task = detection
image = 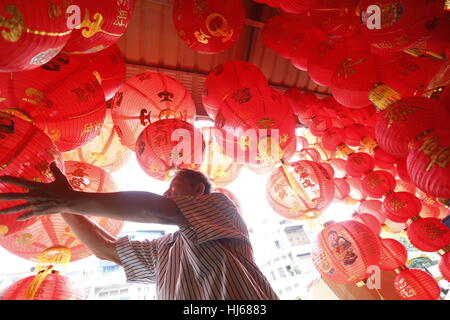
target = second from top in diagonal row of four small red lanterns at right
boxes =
[362,170,395,198]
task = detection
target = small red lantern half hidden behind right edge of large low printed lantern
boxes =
[380,238,408,271]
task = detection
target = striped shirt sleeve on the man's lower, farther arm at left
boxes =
[116,236,158,283]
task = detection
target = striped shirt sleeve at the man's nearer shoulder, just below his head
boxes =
[172,192,249,244]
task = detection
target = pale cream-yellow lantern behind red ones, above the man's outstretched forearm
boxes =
[62,109,131,173]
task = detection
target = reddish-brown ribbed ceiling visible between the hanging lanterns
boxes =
[117,0,330,116]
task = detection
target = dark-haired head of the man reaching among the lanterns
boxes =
[164,169,211,197]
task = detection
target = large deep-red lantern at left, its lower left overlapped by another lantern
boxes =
[0,54,106,151]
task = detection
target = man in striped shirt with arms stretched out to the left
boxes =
[0,163,278,300]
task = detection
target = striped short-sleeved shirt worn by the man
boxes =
[116,193,278,300]
